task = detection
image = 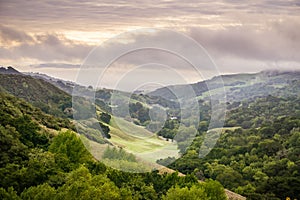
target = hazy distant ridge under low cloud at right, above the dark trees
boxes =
[149,71,300,102]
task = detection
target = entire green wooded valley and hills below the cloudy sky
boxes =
[0,69,300,200]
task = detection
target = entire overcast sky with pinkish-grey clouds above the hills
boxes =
[0,0,300,87]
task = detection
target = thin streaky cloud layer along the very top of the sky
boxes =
[0,0,300,31]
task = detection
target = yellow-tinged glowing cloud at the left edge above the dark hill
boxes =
[0,26,93,62]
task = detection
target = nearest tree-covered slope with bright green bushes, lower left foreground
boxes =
[0,92,226,200]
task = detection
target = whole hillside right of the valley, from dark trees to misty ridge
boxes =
[149,71,300,199]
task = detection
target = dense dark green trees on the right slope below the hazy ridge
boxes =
[169,96,300,199]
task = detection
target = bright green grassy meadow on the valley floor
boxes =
[77,117,178,168]
